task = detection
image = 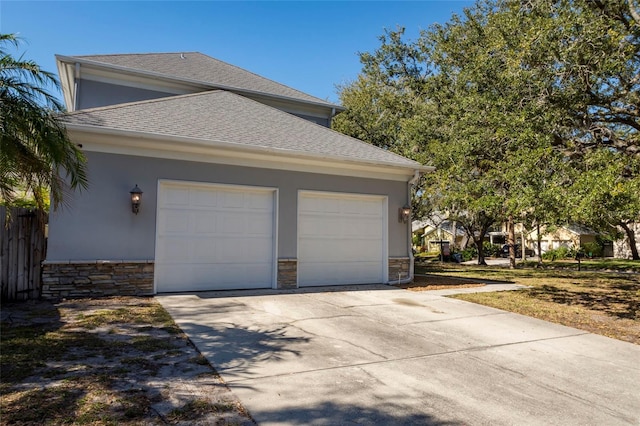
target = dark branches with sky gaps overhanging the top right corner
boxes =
[540,0,640,155]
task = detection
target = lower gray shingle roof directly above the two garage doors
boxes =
[64,90,421,168]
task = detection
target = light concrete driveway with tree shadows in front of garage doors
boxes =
[158,286,640,425]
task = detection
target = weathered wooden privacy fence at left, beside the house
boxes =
[0,206,46,302]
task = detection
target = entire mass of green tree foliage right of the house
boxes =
[334,0,640,263]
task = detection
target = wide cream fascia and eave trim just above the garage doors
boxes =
[67,124,433,181]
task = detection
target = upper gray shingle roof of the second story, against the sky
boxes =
[71,52,336,107]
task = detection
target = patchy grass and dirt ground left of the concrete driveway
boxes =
[0,297,254,425]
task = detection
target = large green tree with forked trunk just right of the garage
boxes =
[336,3,564,265]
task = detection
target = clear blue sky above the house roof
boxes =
[0,0,472,102]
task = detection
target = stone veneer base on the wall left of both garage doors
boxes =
[41,260,154,299]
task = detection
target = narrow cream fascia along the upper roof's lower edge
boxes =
[56,55,345,111]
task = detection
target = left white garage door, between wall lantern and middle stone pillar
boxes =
[155,182,275,292]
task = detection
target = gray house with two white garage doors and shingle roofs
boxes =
[43,52,429,297]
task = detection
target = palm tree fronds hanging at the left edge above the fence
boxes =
[0,34,87,215]
